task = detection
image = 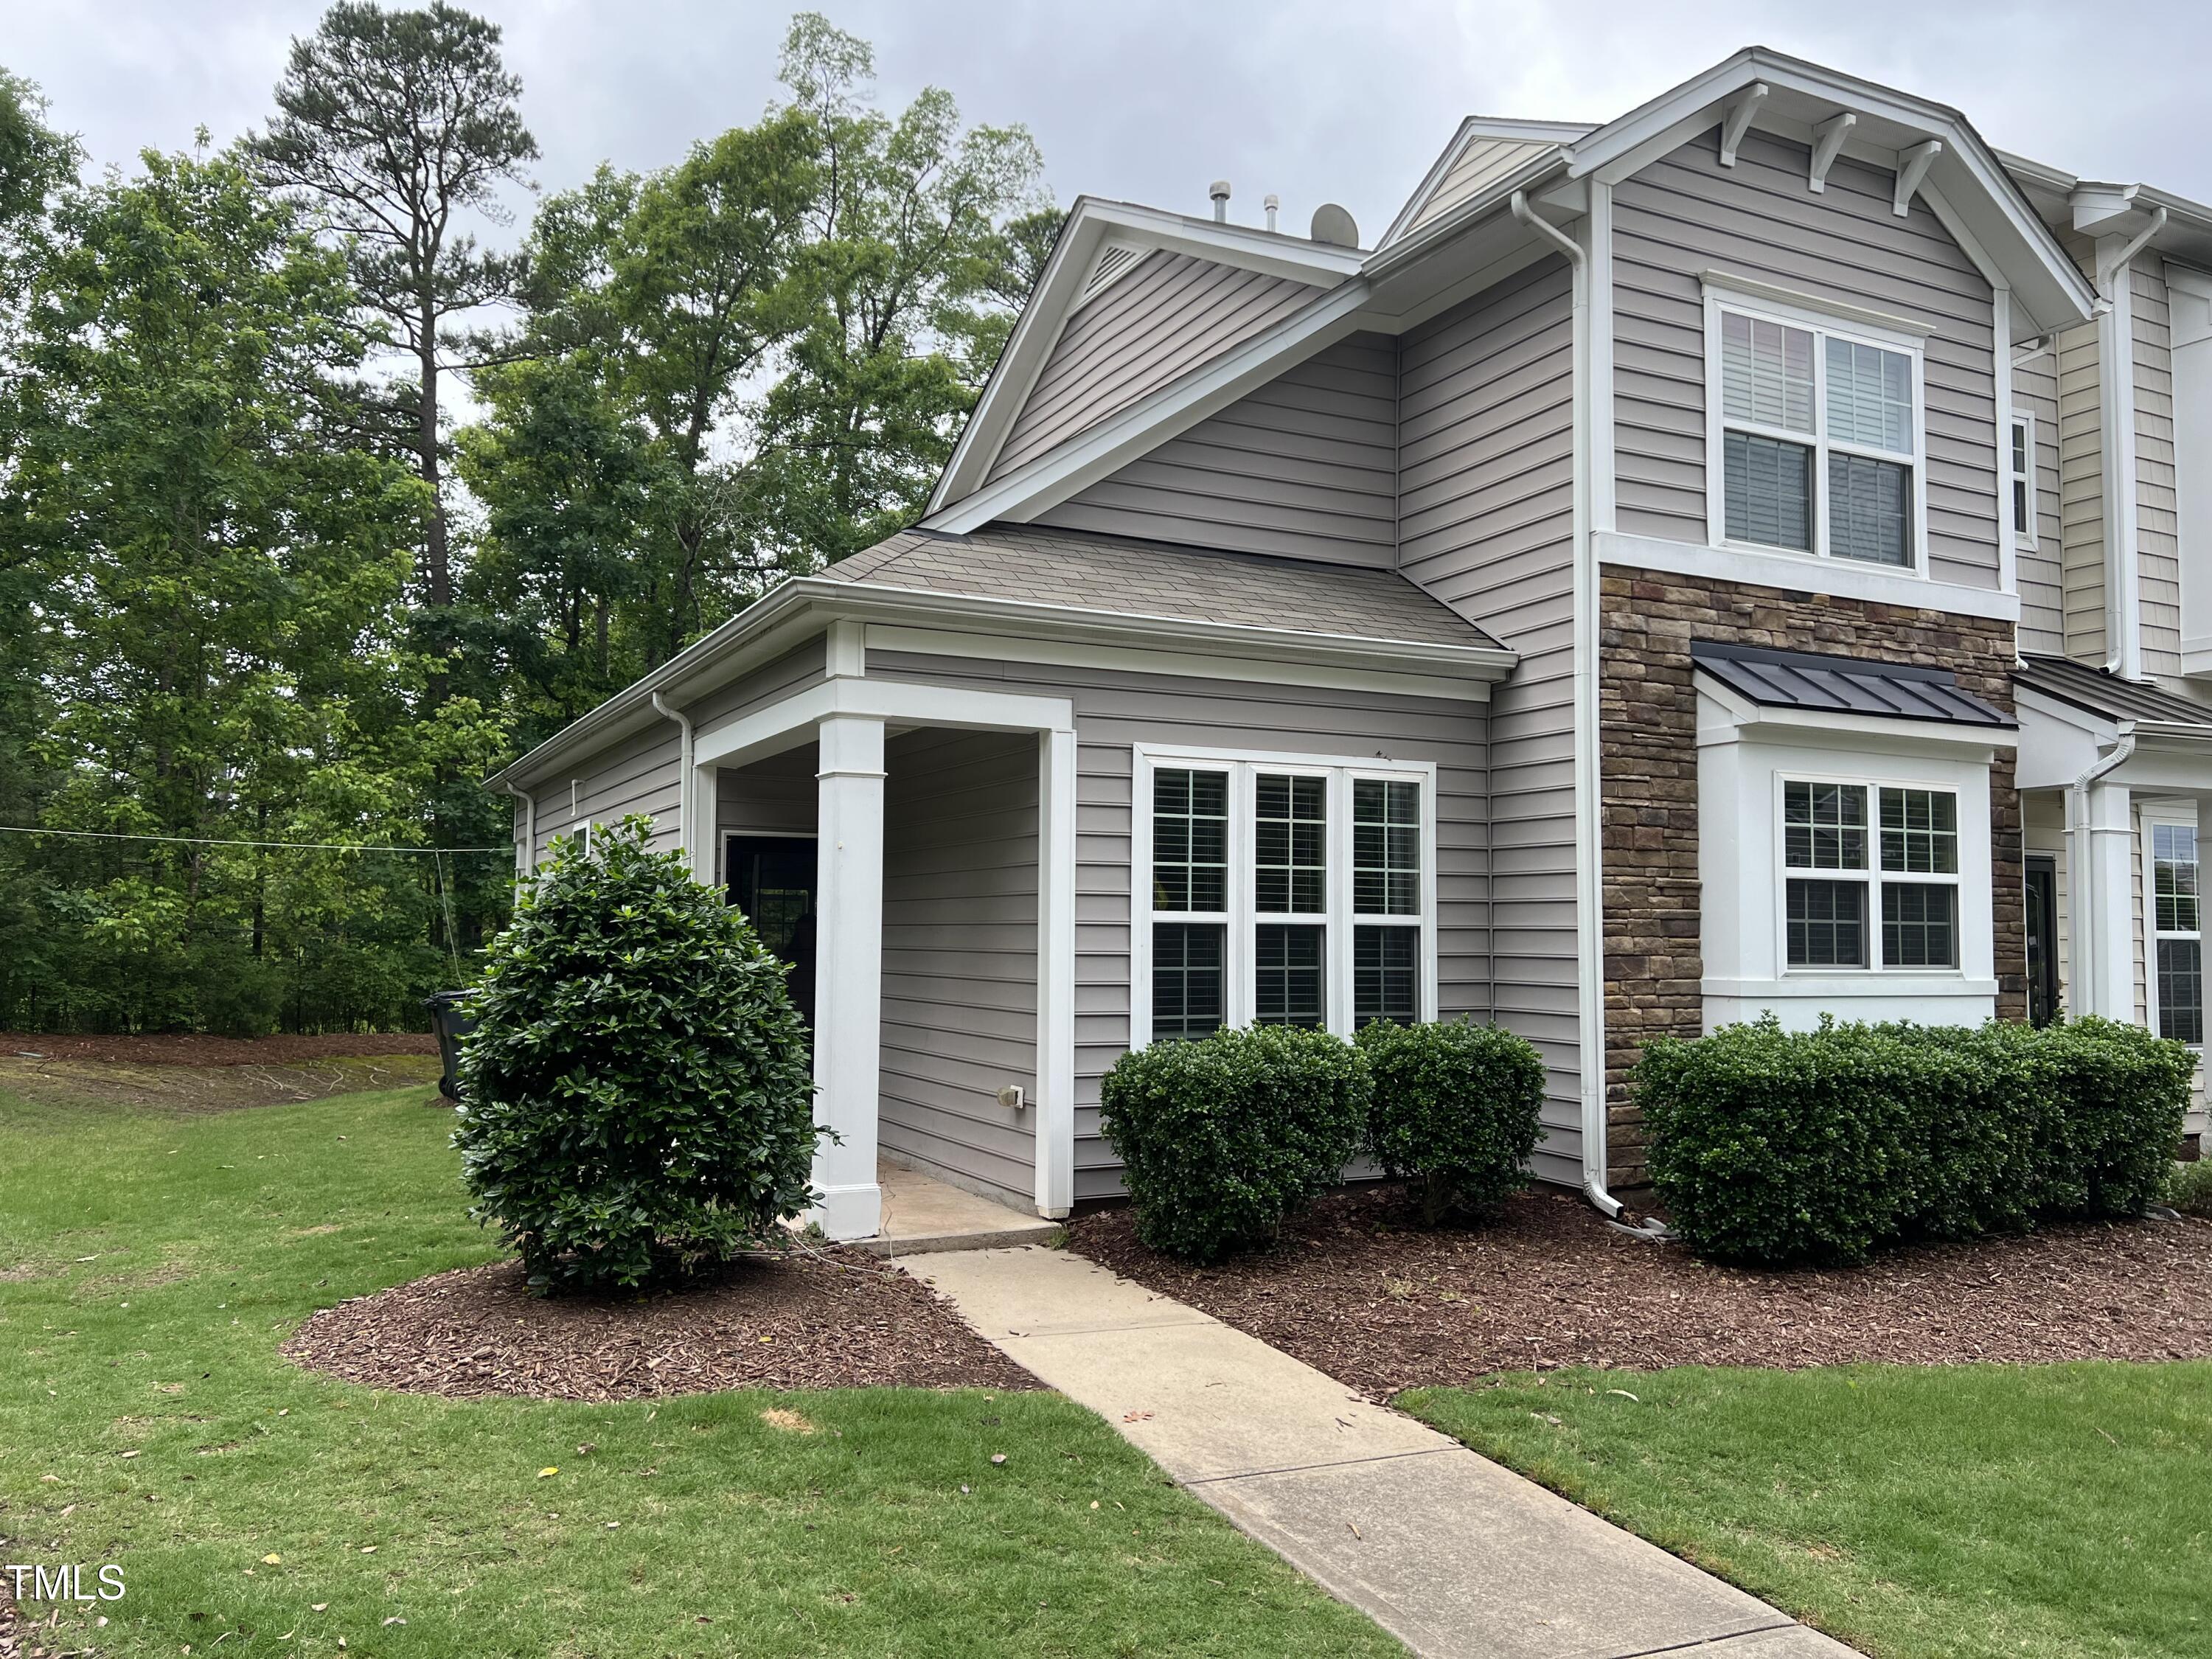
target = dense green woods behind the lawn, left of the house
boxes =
[0,0,1060,1033]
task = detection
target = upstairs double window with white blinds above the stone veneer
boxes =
[1705,288,1924,571]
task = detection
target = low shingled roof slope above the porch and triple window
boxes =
[823,526,1502,650]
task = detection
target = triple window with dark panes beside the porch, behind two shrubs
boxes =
[1133,748,1436,1044]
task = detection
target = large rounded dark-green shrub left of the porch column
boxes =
[453,818,818,1290]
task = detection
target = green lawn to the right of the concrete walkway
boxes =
[1400,1365,2212,1659]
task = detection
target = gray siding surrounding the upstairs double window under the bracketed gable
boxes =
[1613,133,2000,588]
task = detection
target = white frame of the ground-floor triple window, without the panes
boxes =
[1128,743,1438,1048]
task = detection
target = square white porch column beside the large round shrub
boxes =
[810,714,883,1239]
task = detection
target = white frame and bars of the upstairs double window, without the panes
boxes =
[1705,299,1927,575]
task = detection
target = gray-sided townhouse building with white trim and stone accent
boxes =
[493,49,2212,1237]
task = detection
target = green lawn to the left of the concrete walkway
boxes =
[0,1091,1400,1659]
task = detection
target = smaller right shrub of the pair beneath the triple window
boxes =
[1354,1020,1544,1228]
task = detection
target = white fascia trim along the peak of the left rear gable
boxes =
[929,197,1365,513]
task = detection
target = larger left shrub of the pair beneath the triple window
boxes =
[1099,1026,1369,1261]
